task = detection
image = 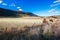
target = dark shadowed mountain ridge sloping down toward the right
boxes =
[0,8,37,17]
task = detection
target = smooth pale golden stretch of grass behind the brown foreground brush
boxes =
[0,18,43,27]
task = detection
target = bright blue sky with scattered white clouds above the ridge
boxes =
[0,0,60,16]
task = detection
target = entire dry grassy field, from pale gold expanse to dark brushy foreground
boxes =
[0,17,60,40]
